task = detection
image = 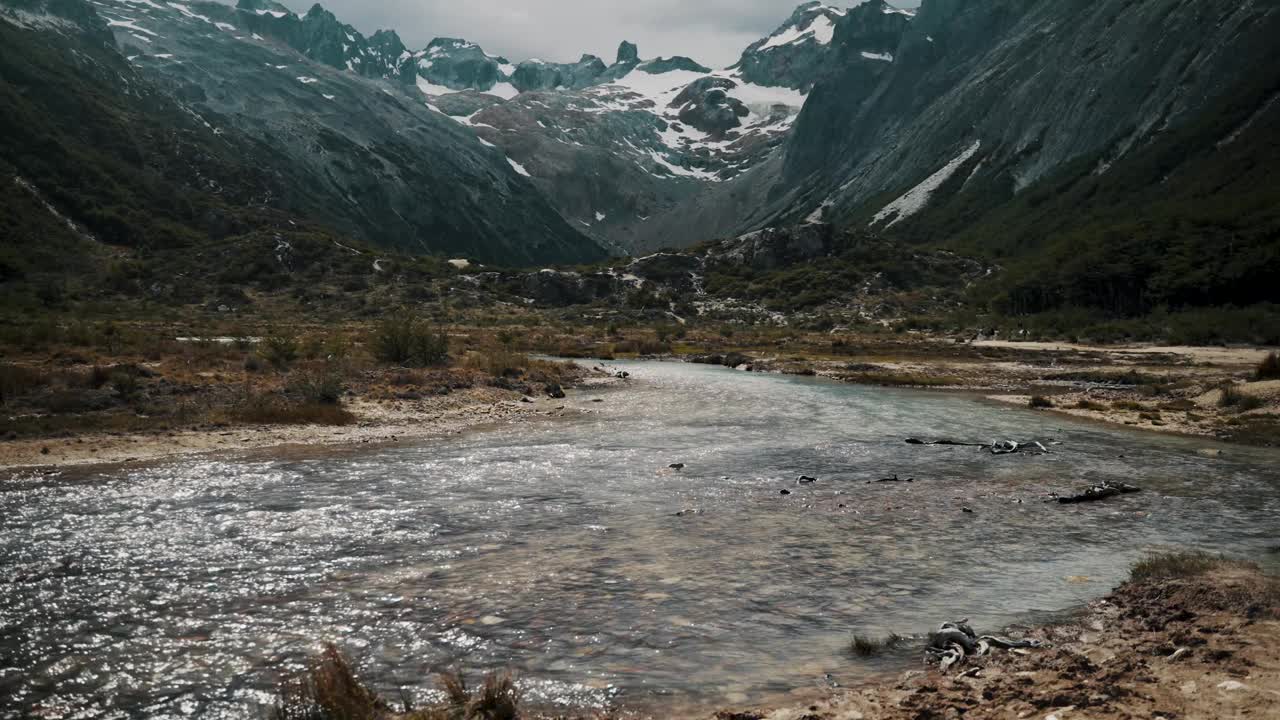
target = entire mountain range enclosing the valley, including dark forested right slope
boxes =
[0,0,1280,327]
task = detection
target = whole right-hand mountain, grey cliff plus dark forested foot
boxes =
[627,0,1280,315]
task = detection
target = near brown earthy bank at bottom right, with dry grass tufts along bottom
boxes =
[282,553,1280,720]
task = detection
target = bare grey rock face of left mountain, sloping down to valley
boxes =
[0,0,604,264]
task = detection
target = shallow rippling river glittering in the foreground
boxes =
[0,363,1280,719]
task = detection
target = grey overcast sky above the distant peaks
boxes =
[267,0,920,67]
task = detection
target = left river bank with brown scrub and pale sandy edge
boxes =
[0,320,620,471]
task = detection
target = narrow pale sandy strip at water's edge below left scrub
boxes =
[0,377,612,471]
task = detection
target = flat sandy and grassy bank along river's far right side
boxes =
[686,338,1280,447]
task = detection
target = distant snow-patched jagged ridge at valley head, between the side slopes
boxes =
[129,0,875,254]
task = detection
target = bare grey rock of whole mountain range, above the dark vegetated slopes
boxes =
[4,0,1280,270]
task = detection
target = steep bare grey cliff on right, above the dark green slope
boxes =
[781,0,1280,228]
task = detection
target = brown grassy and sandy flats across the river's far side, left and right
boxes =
[0,320,1280,470]
